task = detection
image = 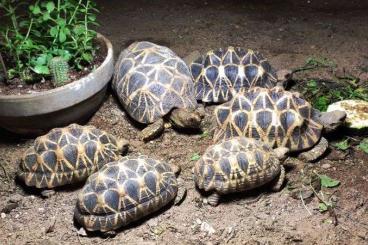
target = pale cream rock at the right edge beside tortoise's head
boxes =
[327,100,368,129]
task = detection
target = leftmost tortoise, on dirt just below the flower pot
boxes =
[18,124,128,197]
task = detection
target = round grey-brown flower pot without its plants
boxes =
[0,34,114,135]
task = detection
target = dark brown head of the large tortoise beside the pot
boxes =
[170,108,203,128]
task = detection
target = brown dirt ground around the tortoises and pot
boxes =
[0,0,368,244]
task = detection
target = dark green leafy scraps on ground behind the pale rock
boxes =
[299,79,368,111]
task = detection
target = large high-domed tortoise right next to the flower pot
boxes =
[113,42,202,141]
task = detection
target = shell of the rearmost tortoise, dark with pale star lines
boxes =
[190,47,277,103]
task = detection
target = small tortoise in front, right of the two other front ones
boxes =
[193,136,288,206]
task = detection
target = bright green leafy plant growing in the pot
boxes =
[0,0,97,81]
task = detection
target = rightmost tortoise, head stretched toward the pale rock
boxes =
[214,87,346,161]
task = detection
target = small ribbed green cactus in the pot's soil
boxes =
[49,57,69,87]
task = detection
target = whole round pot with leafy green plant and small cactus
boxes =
[0,0,113,134]
